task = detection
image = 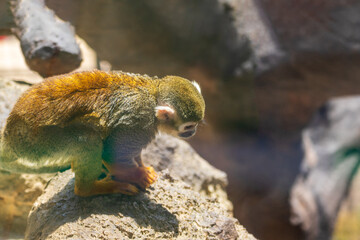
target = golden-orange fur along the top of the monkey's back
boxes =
[8,71,156,128]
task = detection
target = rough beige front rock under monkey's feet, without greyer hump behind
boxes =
[26,170,254,240]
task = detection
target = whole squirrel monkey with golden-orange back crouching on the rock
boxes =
[0,71,205,196]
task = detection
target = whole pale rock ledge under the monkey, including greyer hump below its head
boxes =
[26,135,255,239]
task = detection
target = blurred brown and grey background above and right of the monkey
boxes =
[0,0,360,240]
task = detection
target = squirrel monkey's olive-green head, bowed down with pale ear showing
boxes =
[155,76,205,138]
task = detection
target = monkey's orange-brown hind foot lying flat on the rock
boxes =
[75,178,139,197]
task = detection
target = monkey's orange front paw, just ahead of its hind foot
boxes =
[114,167,157,189]
